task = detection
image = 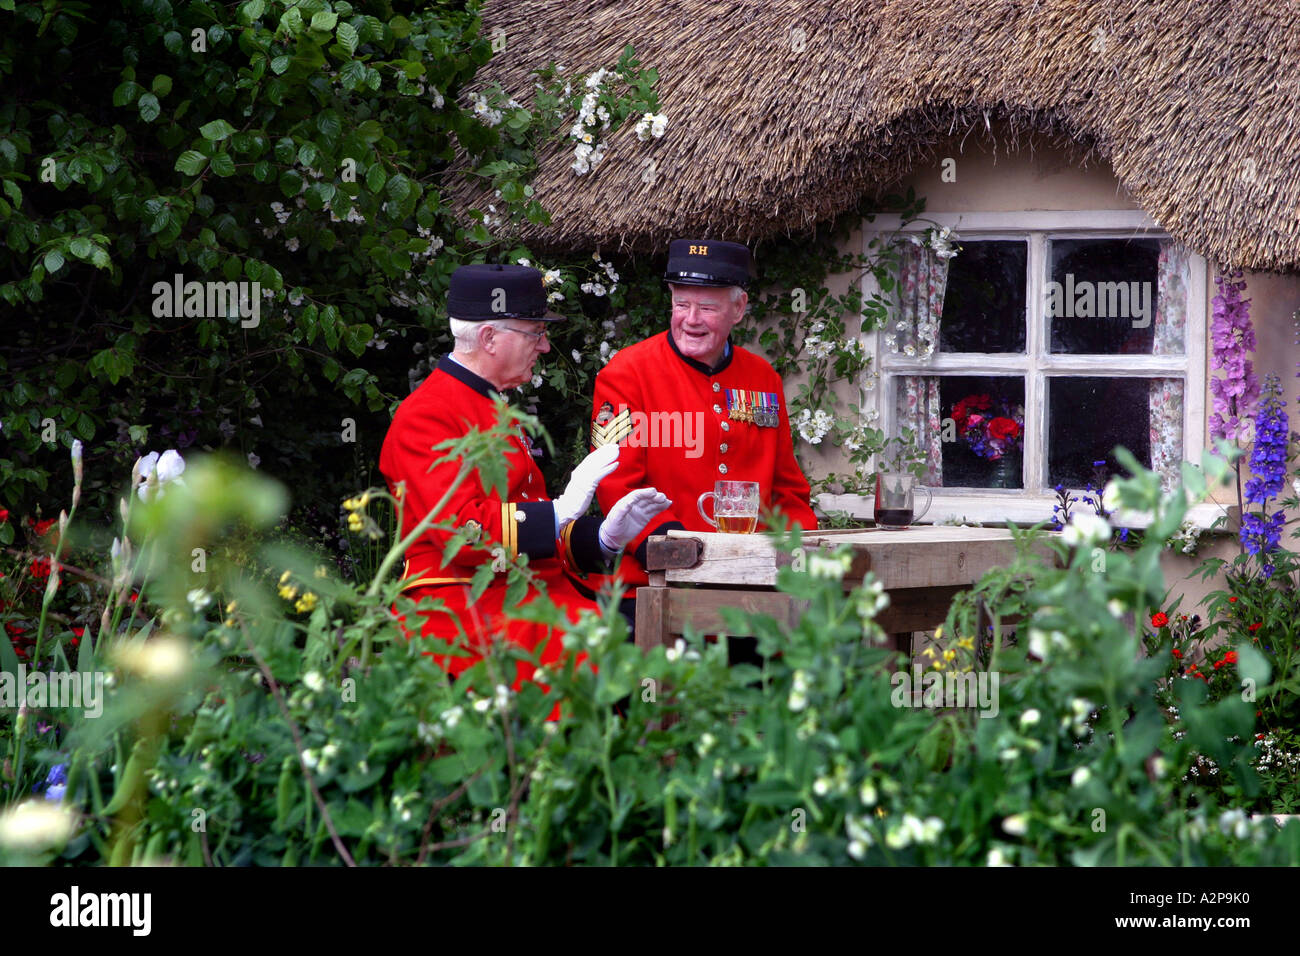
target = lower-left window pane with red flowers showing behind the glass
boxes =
[939,375,1024,488]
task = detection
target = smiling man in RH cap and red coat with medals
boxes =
[592,239,816,642]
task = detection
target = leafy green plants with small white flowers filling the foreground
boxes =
[0,416,1300,865]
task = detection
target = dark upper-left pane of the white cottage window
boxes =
[939,241,1028,354]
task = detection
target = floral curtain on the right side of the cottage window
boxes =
[1148,239,1191,490]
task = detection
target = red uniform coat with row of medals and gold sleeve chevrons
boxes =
[592,332,816,585]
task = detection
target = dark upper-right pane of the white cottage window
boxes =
[1050,239,1164,355]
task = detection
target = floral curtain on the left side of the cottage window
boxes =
[885,237,952,486]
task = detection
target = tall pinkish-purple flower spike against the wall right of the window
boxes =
[1210,269,1260,441]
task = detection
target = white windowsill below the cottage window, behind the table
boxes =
[815,492,1227,529]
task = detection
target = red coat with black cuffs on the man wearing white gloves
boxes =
[380,358,605,689]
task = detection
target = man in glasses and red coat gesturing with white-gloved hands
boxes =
[380,265,671,689]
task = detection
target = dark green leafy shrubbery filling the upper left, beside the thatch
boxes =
[0,0,658,556]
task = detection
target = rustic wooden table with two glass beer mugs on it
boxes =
[636,525,1050,650]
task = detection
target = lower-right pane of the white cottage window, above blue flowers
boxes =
[1047,377,1159,488]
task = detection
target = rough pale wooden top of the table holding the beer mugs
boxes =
[666,527,1047,591]
